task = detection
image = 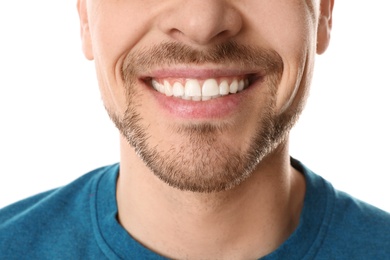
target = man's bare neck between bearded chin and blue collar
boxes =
[117,135,305,259]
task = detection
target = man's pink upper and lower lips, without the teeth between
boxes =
[139,68,263,120]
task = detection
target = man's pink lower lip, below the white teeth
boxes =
[145,80,251,120]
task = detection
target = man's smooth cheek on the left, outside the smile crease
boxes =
[90,1,155,115]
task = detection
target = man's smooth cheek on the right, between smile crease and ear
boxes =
[242,0,316,113]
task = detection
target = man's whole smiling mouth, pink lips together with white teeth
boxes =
[139,68,266,120]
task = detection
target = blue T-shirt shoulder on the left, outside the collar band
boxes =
[0,165,118,259]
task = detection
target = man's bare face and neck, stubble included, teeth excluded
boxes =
[78,0,333,259]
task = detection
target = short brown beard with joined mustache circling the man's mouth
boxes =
[106,42,301,192]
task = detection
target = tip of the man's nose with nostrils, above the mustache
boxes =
[161,0,242,45]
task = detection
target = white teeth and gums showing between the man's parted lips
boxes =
[145,74,259,101]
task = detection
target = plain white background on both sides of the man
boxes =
[0,0,390,211]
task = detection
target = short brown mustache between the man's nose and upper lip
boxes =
[121,41,283,82]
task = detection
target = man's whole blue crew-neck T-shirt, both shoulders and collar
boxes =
[0,159,390,260]
